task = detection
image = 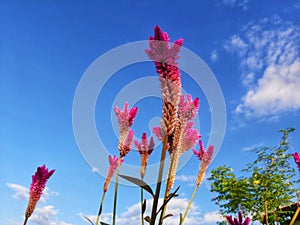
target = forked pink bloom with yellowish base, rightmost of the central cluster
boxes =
[193,140,214,186]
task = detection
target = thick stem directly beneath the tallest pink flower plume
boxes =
[150,135,168,225]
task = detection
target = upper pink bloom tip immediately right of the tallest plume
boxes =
[178,94,199,121]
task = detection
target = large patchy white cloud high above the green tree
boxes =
[224,17,300,118]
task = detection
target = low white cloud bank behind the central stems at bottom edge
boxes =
[79,198,222,225]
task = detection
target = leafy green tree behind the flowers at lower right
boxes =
[209,128,296,225]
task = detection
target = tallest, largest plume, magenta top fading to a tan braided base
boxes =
[146,26,183,136]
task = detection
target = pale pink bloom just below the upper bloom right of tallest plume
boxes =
[180,121,201,153]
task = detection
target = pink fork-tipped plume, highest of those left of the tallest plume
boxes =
[114,102,138,157]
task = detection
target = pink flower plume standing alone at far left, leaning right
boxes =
[25,165,55,220]
